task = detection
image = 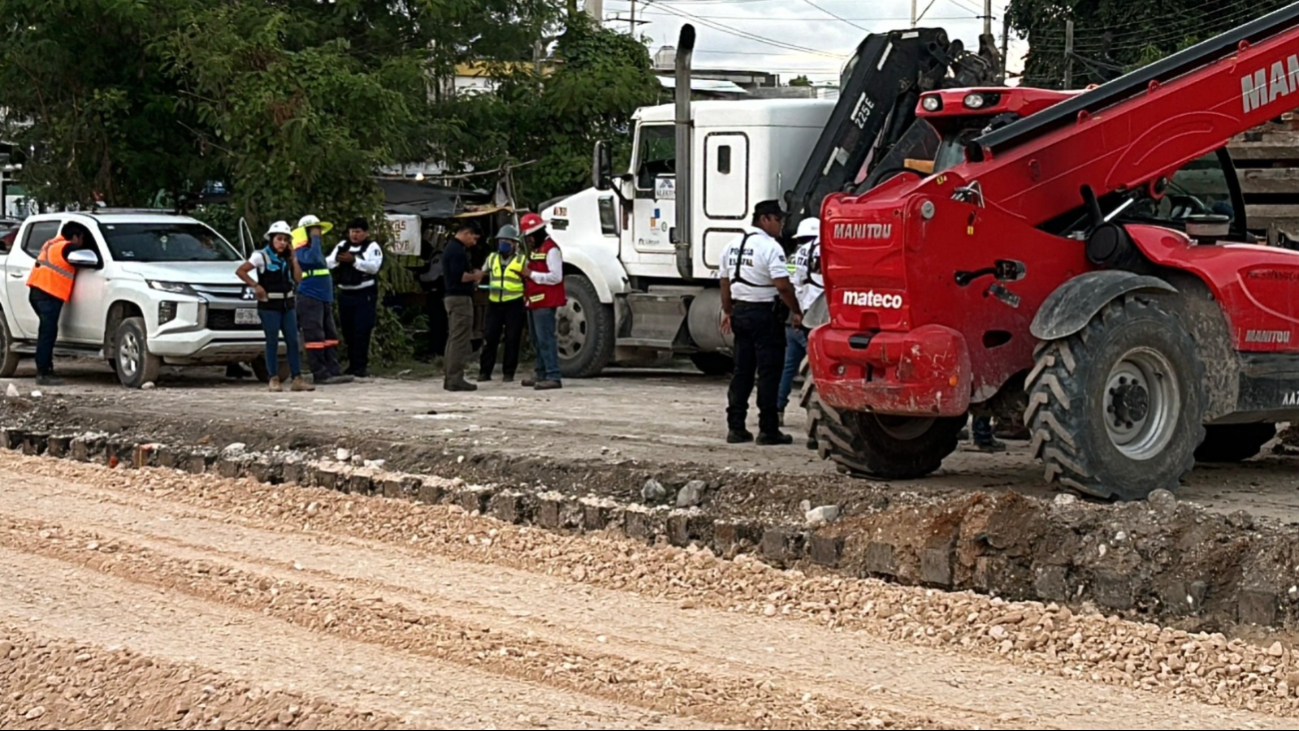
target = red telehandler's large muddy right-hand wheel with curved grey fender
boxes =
[1024,296,1205,500]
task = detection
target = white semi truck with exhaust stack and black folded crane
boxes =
[542,25,995,378]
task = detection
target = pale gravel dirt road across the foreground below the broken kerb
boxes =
[0,453,1299,728]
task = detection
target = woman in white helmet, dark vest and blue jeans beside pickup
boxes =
[235,221,316,391]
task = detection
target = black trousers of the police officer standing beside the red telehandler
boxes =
[726,300,785,434]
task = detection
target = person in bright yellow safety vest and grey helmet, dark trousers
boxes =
[478,225,527,383]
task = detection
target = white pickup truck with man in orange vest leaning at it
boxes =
[0,213,284,388]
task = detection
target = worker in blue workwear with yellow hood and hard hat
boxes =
[294,216,352,384]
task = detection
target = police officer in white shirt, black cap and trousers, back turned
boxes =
[720,200,803,444]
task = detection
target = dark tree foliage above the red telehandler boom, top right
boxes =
[1007,0,1290,88]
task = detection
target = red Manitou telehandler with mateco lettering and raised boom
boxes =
[804,3,1299,500]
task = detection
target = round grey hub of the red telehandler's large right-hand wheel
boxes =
[1103,347,1181,460]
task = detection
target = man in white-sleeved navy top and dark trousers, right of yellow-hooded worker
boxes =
[326,218,383,378]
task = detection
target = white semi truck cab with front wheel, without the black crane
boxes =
[542,99,835,378]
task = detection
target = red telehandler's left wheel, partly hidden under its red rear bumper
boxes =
[803,360,966,479]
